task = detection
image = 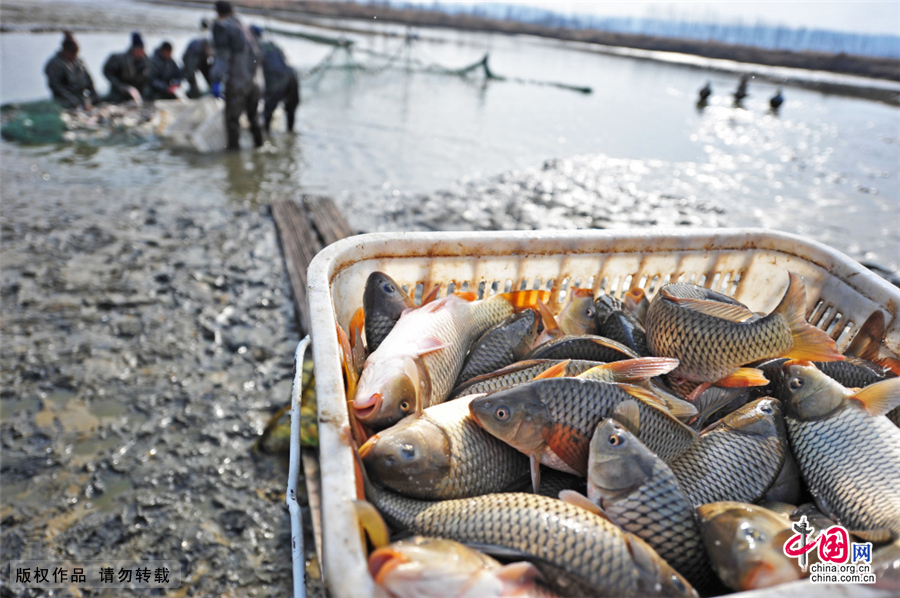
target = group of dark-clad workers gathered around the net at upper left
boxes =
[44,0,300,150]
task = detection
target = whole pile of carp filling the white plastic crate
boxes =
[337,272,900,596]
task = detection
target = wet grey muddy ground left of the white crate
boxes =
[0,146,317,596]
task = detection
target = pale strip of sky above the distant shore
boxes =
[407,0,900,35]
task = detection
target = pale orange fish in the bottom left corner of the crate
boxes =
[369,536,552,598]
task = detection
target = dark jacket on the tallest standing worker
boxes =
[212,16,260,93]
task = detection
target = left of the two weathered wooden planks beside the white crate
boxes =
[271,200,322,336]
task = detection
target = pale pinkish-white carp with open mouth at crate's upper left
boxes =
[352,295,536,430]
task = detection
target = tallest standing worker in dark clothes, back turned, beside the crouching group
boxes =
[212,0,262,150]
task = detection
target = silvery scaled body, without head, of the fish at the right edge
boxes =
[786,405,900,537]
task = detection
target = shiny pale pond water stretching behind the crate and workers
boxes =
[0,1,900,270]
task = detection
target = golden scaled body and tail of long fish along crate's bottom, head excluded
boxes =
[367,488,640,596]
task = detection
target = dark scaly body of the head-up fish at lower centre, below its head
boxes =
[603,459,709,585]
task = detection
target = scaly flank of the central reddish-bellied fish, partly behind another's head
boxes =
[536,378,695,462]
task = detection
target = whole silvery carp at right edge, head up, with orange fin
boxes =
[782,361,900,538]
